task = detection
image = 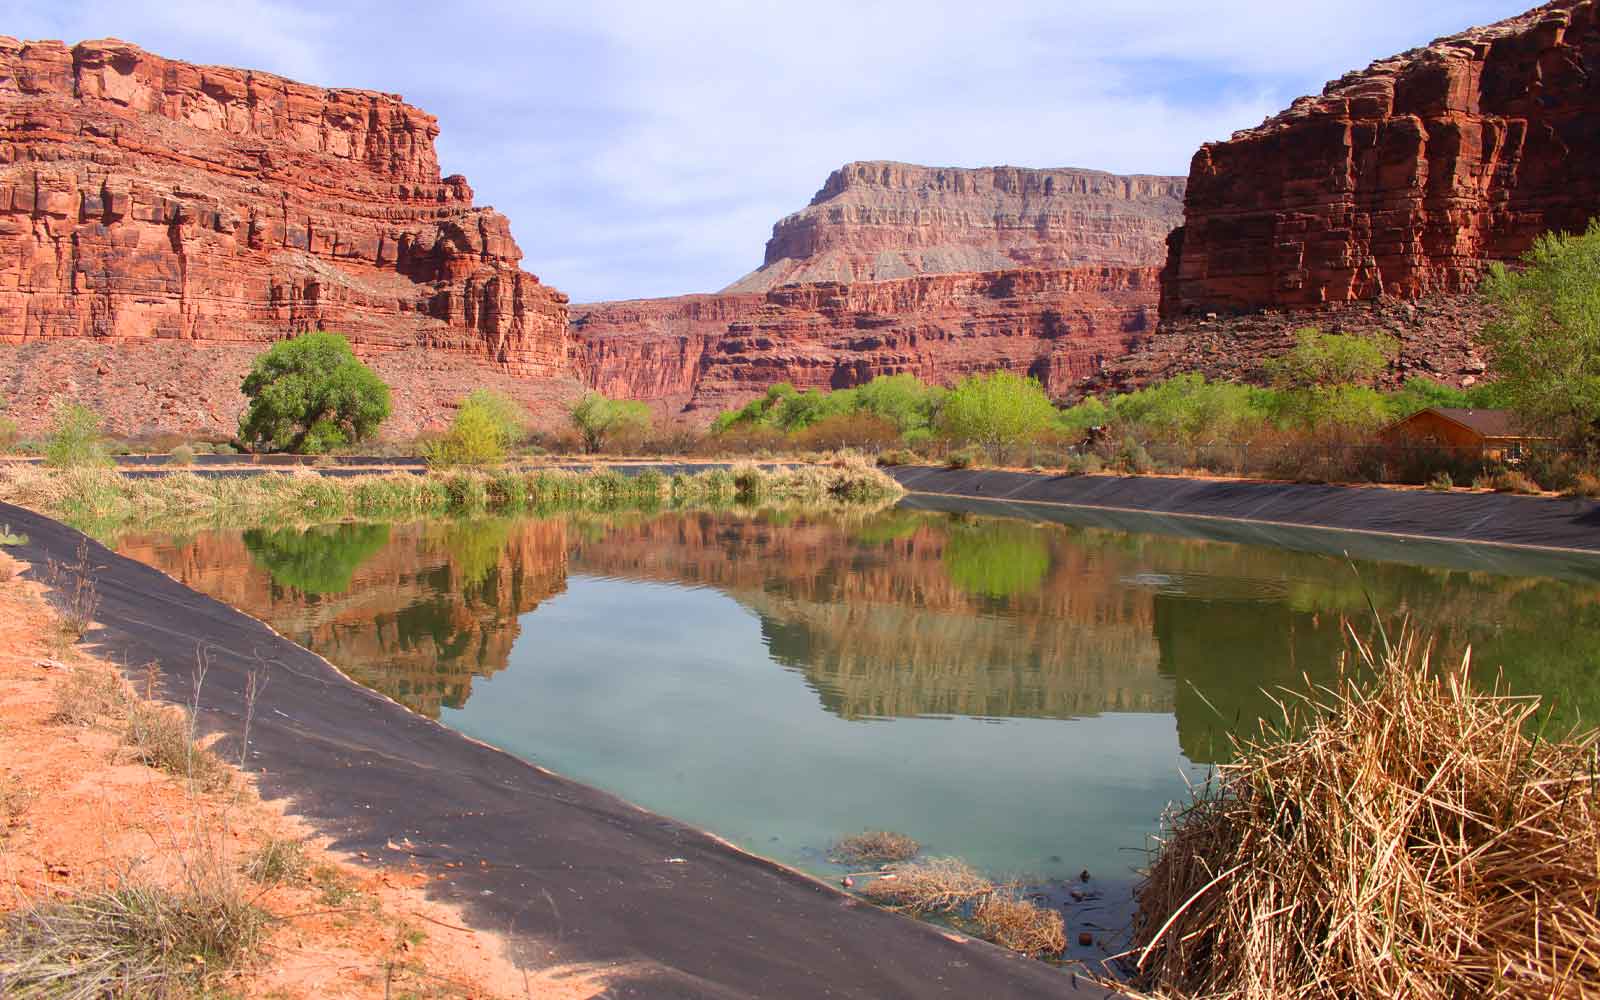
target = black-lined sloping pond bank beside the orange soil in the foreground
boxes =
[0,504,1106,1000]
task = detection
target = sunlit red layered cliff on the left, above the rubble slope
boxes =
[0,38,568,430]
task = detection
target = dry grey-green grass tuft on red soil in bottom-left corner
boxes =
[0,883,266,1000]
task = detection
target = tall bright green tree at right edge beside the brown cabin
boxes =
[1482,221,1600,445]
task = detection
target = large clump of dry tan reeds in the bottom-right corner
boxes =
[1125,637,1600,1000]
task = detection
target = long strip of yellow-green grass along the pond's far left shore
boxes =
[0,461,901,530]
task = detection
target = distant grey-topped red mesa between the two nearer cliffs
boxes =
[573,163,1184,419]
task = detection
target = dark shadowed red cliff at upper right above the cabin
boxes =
[1157,0,1600,378]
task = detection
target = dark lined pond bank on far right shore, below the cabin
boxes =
[886,466,1600,552]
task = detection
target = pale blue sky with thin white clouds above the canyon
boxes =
[15,0,1531,301]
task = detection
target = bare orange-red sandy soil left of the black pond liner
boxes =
[0,550,605,1000]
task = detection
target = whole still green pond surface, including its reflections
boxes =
[112,504,1600,921]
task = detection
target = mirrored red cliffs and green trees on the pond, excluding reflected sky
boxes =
[112,510,1600,762]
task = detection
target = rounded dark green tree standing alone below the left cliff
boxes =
[238,331,389,454]
